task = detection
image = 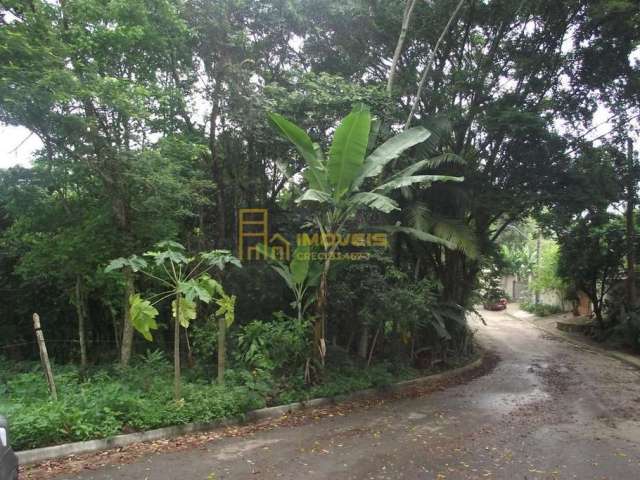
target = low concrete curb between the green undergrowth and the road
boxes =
[16,351,485,465]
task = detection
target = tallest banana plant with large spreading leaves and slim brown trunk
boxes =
[269,105,463,365]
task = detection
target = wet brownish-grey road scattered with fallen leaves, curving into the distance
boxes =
[62,313,640,480]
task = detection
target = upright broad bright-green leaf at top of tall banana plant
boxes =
[327,108,371,199]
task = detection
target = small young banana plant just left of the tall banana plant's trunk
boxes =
[258,244,322,320]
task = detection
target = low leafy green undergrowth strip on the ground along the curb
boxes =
[0,354,478,450]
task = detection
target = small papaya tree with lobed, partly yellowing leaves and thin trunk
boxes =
[105,241,242,400]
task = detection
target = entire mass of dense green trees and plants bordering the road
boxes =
[0,0,640,447]
